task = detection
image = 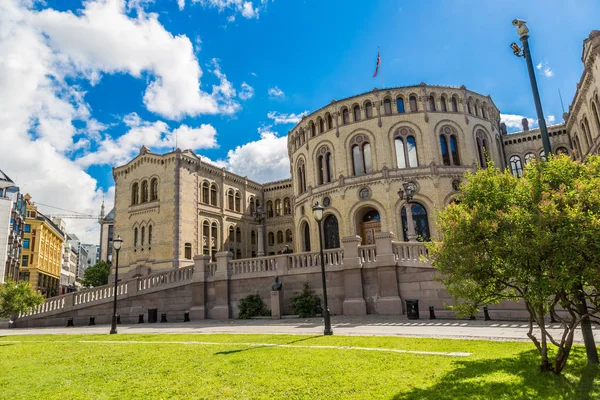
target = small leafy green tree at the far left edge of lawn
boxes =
[0,279,44,320]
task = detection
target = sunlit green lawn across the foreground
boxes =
[0,334,600,400]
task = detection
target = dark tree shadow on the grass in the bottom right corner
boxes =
[393,349,600,400]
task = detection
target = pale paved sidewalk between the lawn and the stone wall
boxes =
[0,315,600,343]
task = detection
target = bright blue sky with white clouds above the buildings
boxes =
[0,0,600,242]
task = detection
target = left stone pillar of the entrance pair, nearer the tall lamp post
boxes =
[342,236,367,315]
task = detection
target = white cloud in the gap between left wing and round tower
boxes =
[219,126,290,182]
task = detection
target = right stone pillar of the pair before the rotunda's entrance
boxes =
[372,232,402,315]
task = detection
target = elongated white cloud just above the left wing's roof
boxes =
[77,113,217,167]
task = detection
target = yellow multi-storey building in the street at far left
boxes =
[20,194,65,297]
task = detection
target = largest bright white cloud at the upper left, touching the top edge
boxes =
[31,0,237,119]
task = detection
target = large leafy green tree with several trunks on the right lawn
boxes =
[428,156,600,374]
